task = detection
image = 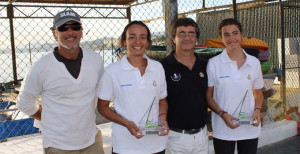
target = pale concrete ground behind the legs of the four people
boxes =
[0,121,300,154]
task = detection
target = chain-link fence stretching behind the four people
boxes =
[0,0,300,152]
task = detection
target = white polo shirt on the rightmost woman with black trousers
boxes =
[207,49,264,140]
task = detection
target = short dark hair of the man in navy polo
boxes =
[171,18,200,39]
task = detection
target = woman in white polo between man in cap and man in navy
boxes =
[97,21,169,154]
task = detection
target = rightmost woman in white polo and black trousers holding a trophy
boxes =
[207,18,263,154]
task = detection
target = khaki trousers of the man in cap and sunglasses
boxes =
[44,130,104,154]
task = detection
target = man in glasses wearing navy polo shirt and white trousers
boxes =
[161,18,208,154]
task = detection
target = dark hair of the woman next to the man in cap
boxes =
[119,20,152,49]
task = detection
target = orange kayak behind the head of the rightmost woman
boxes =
[204,37,269,51]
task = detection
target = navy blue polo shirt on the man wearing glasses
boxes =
[161,51,207,130]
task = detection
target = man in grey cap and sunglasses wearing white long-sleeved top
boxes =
[17,10,104,154]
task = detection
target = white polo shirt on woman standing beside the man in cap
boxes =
[97,55,167,154]
